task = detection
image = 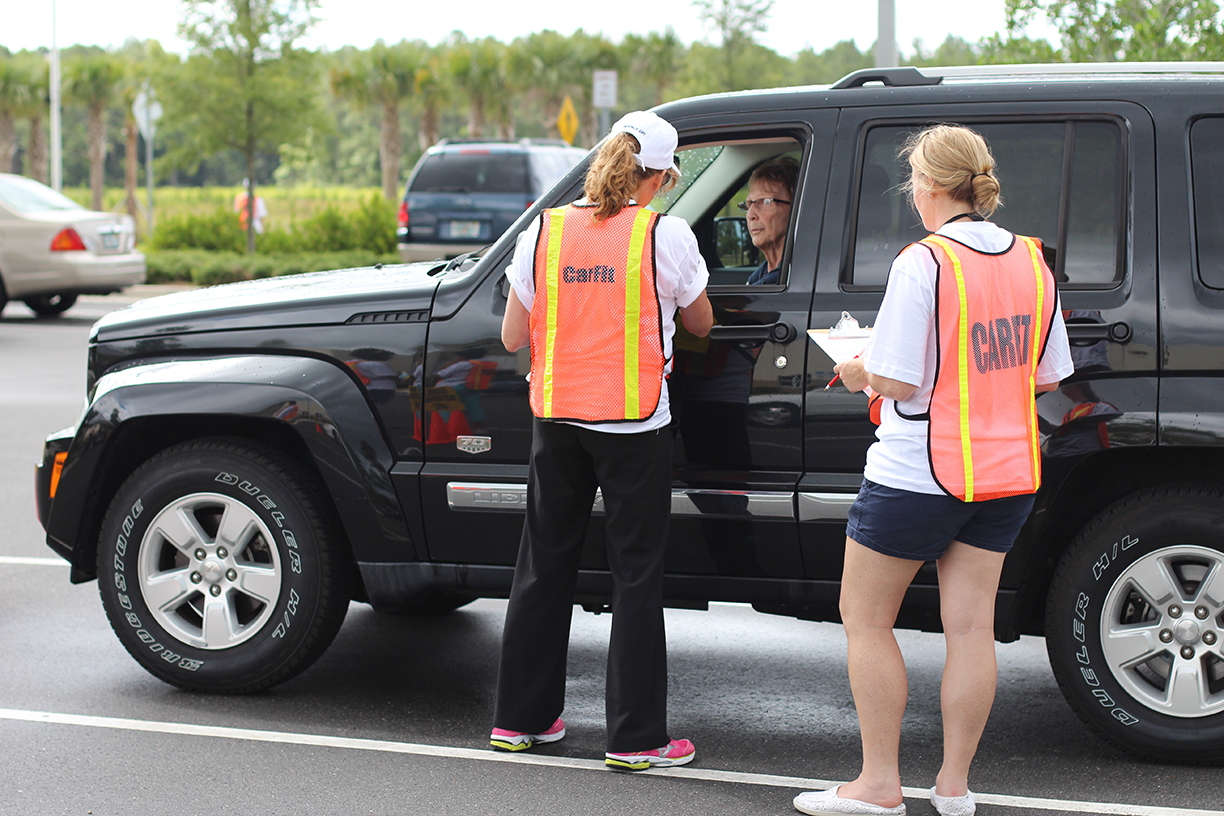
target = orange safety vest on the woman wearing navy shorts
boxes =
[920,235,1058,502]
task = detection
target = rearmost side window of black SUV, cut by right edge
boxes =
[1190,119,1224,289]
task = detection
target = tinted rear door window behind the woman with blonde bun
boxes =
[843,121,1125,289]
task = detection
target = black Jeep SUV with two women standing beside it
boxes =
[37,64,1224,762]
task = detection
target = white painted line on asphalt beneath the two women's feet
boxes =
[0,708,1224,816]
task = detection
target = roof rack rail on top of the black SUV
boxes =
[834,61,1224,88]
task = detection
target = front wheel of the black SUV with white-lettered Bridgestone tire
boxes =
[98,439,354,694]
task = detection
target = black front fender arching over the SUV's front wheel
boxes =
[44,355,416,581]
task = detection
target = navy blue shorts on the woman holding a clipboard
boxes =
[846,478,1034,562]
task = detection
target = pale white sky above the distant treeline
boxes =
[0,0,1045,56]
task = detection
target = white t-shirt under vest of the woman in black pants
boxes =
[506,202,710,433]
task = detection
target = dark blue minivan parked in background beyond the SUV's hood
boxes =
[395,138,586,262]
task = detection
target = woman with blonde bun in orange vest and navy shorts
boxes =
[794,125,1073,816]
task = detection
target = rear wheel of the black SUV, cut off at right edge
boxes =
[1045,484,1224,763]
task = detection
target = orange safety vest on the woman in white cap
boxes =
[529,204,667,422]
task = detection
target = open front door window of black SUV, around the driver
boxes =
[650,137,802,286]
